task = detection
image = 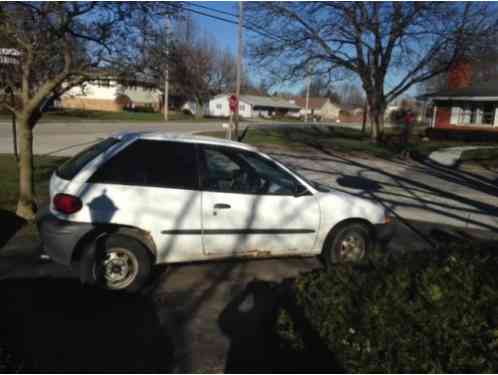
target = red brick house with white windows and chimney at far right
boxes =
[426,62,498,131]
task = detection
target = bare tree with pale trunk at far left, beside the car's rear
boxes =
[0,2,176,219]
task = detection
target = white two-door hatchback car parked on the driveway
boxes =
[38,132,393,291]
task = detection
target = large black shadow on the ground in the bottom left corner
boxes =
[0,279,172,372]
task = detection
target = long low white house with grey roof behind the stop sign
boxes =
[209,94,299,118]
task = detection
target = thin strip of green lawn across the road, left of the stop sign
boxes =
[0,109,219,122]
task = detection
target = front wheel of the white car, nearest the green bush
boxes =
[322,222,373,268]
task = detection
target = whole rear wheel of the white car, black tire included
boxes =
[80,234,152,293]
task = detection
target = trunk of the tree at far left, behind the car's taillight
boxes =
[16,117,36,220]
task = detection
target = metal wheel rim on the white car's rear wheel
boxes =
[101,248,138,289]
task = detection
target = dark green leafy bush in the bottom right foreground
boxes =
[276,247,498,373]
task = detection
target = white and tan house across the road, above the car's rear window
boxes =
[59,79,161,112]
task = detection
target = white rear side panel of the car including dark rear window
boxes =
[80,139,204,262]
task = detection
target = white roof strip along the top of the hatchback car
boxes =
[111,131,258,151]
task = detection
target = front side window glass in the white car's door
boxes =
[203,147,306,195]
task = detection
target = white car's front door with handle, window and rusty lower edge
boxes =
[200,145,319,256]
